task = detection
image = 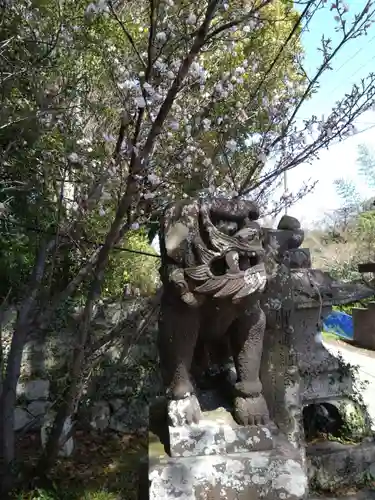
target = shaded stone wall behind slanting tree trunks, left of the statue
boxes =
[4,297,162,432]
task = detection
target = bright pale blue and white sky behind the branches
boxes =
[287,0,375,226]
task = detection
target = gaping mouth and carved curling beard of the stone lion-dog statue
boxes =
[185,250,266,300]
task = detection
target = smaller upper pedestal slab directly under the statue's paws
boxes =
[169,408,273,457]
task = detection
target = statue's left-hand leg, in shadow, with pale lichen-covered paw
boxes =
[158,294,200,425]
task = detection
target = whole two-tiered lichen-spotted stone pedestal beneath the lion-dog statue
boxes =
[149,401,307,500]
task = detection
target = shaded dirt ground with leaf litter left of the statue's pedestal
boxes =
[17,430,147,500]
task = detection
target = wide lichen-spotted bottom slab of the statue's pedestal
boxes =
[149,433,308,500]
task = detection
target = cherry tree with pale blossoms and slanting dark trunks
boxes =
[0,0,375,490]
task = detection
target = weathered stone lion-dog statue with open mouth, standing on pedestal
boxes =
[158,199,269,425]
